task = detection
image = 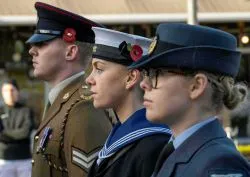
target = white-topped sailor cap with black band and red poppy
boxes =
[92,27,151,66]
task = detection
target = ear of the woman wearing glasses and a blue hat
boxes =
[189,73,208,100]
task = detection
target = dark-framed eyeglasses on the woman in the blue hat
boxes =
[141,68,194,89]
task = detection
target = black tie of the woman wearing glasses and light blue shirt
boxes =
[152,141,175,177]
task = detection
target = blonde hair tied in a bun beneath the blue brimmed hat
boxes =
[205,73,247,111]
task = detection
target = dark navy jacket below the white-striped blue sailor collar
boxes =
[88,134,170,177]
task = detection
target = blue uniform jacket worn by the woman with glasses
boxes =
[157,119,250,177]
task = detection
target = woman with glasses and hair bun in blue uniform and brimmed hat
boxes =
[129,23,250,177]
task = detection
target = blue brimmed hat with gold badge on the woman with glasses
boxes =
[129,23,241,77]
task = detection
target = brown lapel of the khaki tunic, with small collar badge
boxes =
[37,76,83,132]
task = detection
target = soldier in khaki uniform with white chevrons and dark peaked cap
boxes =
[27,2,111,177]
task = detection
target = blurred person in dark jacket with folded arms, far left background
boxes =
[0,80,34,177]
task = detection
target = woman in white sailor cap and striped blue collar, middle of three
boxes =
[86,27,170,177]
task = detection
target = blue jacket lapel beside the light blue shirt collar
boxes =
[157,119,226,177]
